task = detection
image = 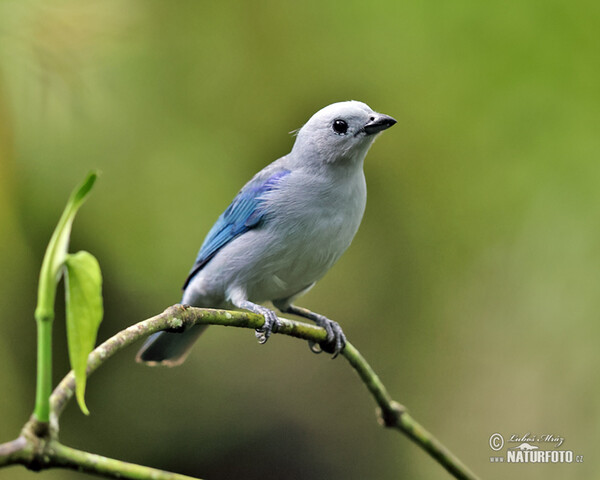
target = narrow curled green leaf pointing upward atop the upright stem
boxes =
[35,172,98,321]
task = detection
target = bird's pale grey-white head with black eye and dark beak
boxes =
[292,100,396,163]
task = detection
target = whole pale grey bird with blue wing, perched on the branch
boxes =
[136,100,396,366]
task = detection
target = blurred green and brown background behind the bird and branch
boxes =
[0,0,600,480]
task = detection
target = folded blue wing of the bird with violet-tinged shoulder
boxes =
[183,170,291,289]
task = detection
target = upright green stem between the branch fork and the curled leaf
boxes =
[33,317,52,423]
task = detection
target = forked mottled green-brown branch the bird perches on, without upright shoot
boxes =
[0,305,477,480]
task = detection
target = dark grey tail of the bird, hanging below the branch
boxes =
[135,325,207,367]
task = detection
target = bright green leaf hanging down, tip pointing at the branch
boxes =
[65,251,103,415]
